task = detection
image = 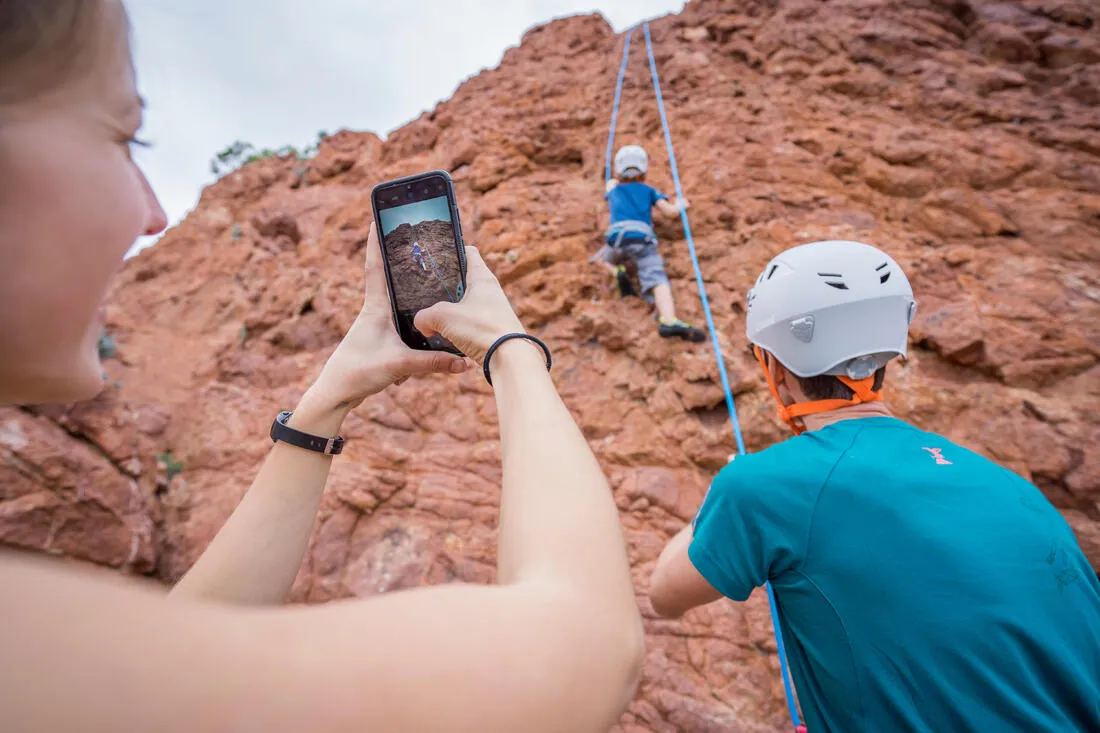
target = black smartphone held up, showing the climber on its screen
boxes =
[371,171,466,355]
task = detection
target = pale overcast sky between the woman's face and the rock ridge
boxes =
[127,0,684,254]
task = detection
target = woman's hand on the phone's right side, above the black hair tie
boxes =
[414,247,527,363]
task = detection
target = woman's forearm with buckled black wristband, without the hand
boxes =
[172,393,348,603]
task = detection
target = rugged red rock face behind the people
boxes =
[0,0,1100,733]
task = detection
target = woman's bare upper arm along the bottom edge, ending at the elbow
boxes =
[0,554,638,733]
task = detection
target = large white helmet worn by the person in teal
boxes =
[745,241,916,380]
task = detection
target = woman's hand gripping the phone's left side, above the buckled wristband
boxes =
[309,223,469,407]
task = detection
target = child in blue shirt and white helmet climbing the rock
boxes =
[597,145,706,342]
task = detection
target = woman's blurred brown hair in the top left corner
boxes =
[0,0,129,107]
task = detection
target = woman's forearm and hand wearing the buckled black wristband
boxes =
[172,225,466,603]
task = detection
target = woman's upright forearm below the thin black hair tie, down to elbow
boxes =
[492,340,637,613]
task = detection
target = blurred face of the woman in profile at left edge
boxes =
[0,15,166,404]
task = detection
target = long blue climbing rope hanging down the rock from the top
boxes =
[606,22,806,733]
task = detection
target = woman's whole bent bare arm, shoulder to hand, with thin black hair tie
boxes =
[0,250,644,733]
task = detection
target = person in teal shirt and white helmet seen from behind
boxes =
[649,241,1100,733]
